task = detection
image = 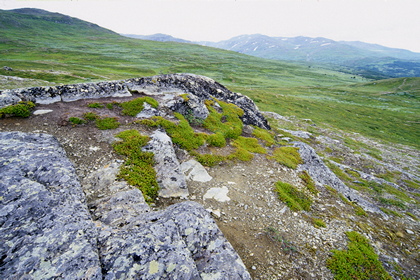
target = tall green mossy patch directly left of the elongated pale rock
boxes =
[113,130,159,203]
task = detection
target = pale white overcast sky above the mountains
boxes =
[0,0,420,52]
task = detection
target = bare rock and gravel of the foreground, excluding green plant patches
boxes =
[0,74,419,279]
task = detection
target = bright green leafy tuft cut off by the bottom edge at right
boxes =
[327,231,392,280]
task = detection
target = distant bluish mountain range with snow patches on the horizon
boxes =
[125,34,420,79]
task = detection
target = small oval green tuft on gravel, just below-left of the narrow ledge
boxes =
[274,181,312,211]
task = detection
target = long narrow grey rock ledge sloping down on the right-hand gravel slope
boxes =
[294,142,385,215]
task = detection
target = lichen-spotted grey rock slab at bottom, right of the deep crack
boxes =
[99,202,251,279]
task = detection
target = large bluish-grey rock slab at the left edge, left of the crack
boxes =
[0,132,102,279]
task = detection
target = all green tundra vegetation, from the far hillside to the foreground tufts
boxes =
[0,8,420,279]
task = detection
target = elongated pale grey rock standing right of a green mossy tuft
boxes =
[143,130,188,198]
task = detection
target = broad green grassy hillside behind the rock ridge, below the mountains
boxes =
[0,10,420,147]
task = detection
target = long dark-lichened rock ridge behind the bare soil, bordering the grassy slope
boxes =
[0,74,270,129]
